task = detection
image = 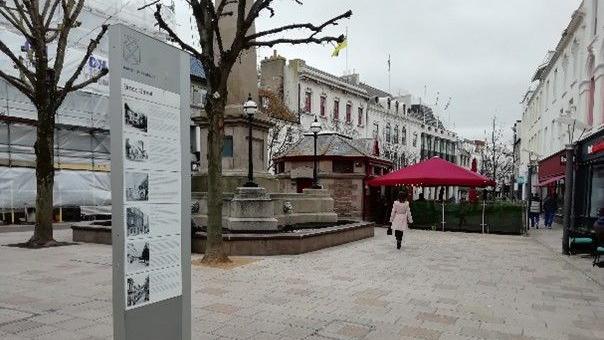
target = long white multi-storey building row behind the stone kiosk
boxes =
[260,52,457,175]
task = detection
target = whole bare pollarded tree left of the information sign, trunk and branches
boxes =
[0,0,107,247]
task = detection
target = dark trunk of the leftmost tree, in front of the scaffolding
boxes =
[27,100,56,247]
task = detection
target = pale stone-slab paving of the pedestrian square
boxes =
[0,229,604,340]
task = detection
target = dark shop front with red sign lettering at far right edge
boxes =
[574,130,604,227]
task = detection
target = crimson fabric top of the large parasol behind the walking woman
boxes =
[368,157,495,187]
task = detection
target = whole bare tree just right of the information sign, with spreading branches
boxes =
[155,0,352,263]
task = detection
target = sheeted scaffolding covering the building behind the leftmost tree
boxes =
[0,0,174,223]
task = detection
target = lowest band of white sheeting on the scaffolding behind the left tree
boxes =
[0,167,111,209]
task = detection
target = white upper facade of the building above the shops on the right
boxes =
[518,0,604,197]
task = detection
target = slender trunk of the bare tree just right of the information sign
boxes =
[202,99,230,263]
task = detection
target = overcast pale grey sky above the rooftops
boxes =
[250,0,580,138]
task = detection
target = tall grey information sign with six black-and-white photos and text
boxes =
[109,25,191,340]
